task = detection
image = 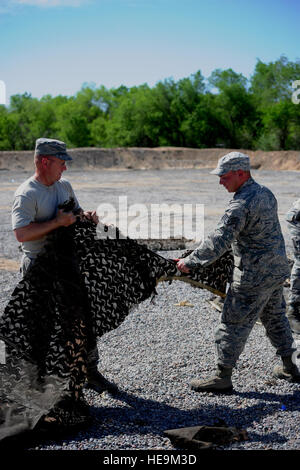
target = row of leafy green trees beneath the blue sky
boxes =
[0,56,300,150]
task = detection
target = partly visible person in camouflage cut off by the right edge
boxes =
[286,199,300,335]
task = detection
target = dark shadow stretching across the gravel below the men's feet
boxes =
[0,390,300,451]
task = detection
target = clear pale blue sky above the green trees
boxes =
[0,0,300,102]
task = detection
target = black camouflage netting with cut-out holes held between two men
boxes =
[0,198,233,440]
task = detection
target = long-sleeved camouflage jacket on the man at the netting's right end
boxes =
[185,178,290,289]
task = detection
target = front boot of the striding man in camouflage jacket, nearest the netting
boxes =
[190,364,233,393]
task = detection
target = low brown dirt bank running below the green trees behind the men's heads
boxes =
[0,147,300,171]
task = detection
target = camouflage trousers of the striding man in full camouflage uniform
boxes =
[215,283,296,368]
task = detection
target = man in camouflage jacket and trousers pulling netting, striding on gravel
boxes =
[177,152,300,392]
